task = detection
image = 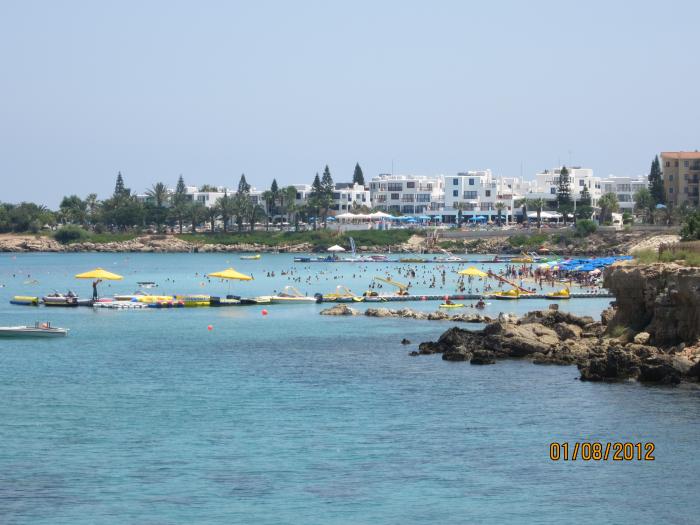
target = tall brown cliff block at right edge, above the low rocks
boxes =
[604,263,700,348]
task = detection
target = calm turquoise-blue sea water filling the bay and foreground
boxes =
[0,254,700,524]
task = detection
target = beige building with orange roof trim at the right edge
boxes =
[661,150,700,206]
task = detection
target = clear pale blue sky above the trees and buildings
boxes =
[0,0,700,207]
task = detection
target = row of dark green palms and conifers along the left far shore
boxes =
[0,164,364,233]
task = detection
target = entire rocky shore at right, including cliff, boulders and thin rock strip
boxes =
[321,264,700,384]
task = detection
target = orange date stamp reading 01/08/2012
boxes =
[549,441,656,461]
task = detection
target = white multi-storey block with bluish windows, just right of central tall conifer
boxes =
[369,174,445,215]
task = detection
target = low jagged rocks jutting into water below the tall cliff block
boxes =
[411,310,700,384]
